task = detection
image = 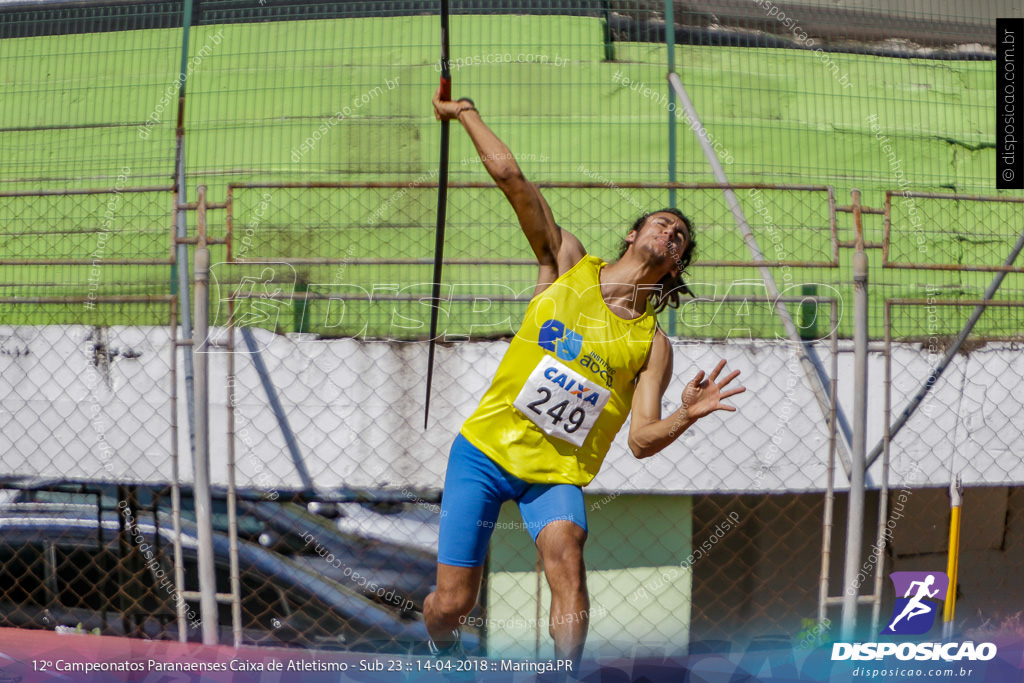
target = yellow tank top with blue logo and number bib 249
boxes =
[462,256,657,486]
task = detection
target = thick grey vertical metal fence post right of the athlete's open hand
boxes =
[842,189,867,641]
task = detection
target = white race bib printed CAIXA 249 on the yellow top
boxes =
[512,355,611,446]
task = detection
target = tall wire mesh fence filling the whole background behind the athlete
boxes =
[0,2,1024,667]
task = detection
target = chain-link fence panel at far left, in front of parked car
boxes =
[0,185,184,638]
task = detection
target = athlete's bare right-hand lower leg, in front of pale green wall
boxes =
[537,519,590,671]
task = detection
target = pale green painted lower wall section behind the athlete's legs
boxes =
[486,495,692,658]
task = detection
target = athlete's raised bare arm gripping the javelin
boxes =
[433,89,587,285]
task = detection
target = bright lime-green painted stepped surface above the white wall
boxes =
[0,15,1022,338]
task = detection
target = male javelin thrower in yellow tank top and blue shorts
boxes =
[424,94,743,663]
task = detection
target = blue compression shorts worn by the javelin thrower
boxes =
[437,434,587,567]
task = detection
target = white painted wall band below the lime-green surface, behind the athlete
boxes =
[0,326,1024,494]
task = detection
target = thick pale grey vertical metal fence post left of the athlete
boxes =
[193,185,218,645]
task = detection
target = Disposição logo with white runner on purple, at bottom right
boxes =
[831,571,996,661]
